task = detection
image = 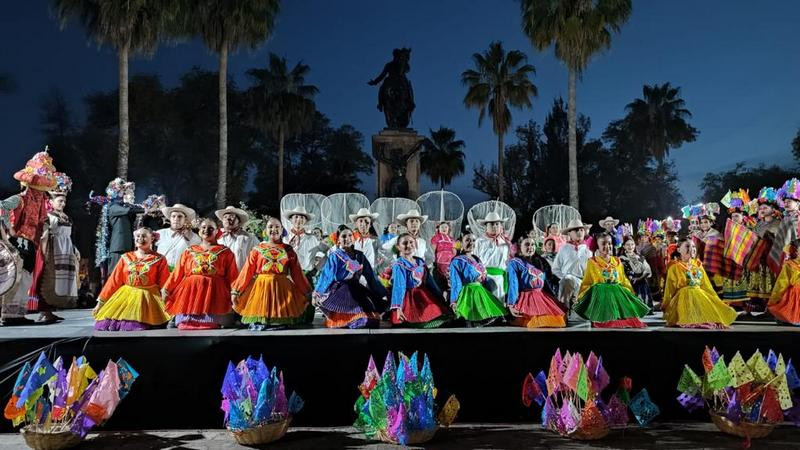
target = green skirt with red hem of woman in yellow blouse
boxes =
[575,283,650,328]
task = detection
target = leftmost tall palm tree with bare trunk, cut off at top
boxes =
[53,0,173,179]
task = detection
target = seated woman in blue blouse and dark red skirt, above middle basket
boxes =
[390,233,452,328]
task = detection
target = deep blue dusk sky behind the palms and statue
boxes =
[0,0,800,207]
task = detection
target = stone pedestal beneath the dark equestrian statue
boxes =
[372,128,424,200]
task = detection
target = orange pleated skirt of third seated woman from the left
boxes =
[234,273,309,325]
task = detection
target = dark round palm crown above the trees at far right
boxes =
[625,82,699,162]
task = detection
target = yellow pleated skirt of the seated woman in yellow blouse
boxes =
[664,286,737,328]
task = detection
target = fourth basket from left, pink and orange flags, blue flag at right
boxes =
[522,349,660,440]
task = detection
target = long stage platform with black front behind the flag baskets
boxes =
[0,310,800,432]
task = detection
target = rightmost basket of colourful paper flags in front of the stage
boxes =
[678,347,800,439]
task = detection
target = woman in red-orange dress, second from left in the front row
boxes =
[164,219,238,330]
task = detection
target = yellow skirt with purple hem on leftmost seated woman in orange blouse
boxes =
[94,285,170,331]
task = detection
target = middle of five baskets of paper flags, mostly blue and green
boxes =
[353,352,460,445]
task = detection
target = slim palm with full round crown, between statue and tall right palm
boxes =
[461,41,538,200]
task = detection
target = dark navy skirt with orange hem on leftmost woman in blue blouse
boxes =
[319,279,386,328]
